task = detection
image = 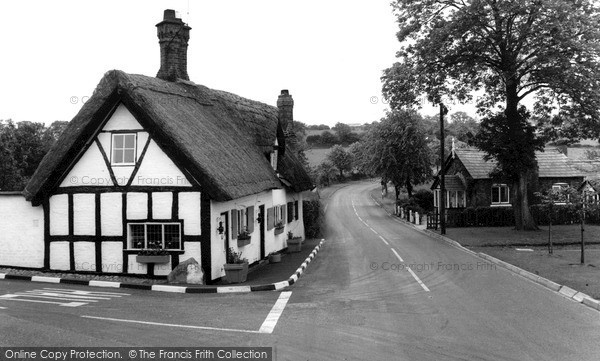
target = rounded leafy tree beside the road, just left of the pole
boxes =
[357,110,432,197]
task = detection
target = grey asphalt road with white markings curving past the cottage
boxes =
[0,183,600,361]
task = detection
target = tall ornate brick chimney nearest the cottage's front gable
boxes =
[156,10,191,81]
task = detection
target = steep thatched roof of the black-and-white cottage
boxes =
[24,70,312,203]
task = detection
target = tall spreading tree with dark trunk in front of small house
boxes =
[382,0,600,229]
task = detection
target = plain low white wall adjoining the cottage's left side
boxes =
[0,194,44,268]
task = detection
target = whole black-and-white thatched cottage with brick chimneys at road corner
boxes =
[0,10,312,282]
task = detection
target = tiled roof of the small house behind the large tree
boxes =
[455,148,586,179]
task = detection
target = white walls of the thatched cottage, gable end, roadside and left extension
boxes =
[0,103,304,282]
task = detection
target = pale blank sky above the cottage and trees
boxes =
[0,0,475,126]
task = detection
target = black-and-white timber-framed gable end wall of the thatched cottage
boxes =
[46,103,202,276]
